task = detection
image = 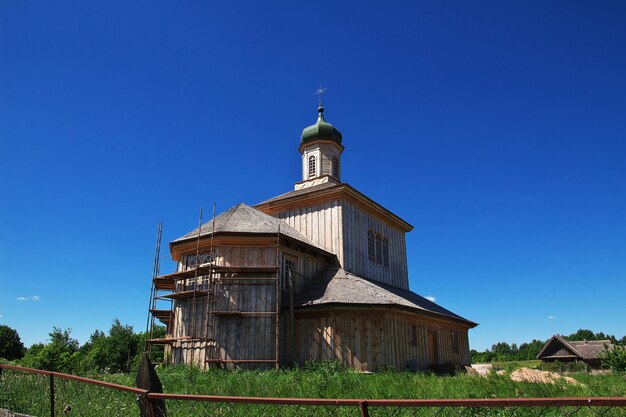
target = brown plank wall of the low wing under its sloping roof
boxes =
[295,311,469,371]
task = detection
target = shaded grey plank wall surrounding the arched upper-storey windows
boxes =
[341,201,409,289]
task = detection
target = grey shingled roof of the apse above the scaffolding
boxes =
[172,203,329,253]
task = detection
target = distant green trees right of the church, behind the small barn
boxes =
[470,329,626,363]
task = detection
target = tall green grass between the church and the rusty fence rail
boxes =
[94,363,626,399]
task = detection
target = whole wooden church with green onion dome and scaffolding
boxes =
[150,103,476,371]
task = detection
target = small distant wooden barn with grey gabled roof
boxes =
[537,334,615,368]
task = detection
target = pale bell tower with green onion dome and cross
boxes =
[296,102,344,190]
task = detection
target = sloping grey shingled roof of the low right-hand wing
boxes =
[294,267,477,327]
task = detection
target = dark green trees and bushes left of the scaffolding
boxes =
[0,319,165,374]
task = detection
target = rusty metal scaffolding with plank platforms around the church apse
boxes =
[148,213,280,369]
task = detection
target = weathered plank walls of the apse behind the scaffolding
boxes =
[168,242,326,369]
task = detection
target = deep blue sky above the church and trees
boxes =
[0,1,626,350]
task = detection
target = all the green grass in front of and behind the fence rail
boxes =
[0,363,626,417]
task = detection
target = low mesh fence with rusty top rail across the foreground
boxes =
[0,364,626,417]
